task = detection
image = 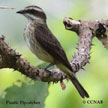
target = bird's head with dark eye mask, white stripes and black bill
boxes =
[16,5,46,22]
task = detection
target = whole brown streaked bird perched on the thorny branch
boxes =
[16,5,89,98]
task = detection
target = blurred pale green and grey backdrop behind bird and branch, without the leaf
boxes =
[0,0,108,108]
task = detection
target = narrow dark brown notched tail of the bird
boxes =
[69,75,89,98]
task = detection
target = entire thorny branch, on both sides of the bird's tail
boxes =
[0,18,108,82]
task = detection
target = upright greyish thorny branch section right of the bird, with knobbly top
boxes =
[63,18,108,73]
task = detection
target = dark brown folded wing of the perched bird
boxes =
[34,25,72,71]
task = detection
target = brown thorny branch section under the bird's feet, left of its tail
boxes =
[0,36,66,82]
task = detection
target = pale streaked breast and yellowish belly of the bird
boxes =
[24,24,54,63]
